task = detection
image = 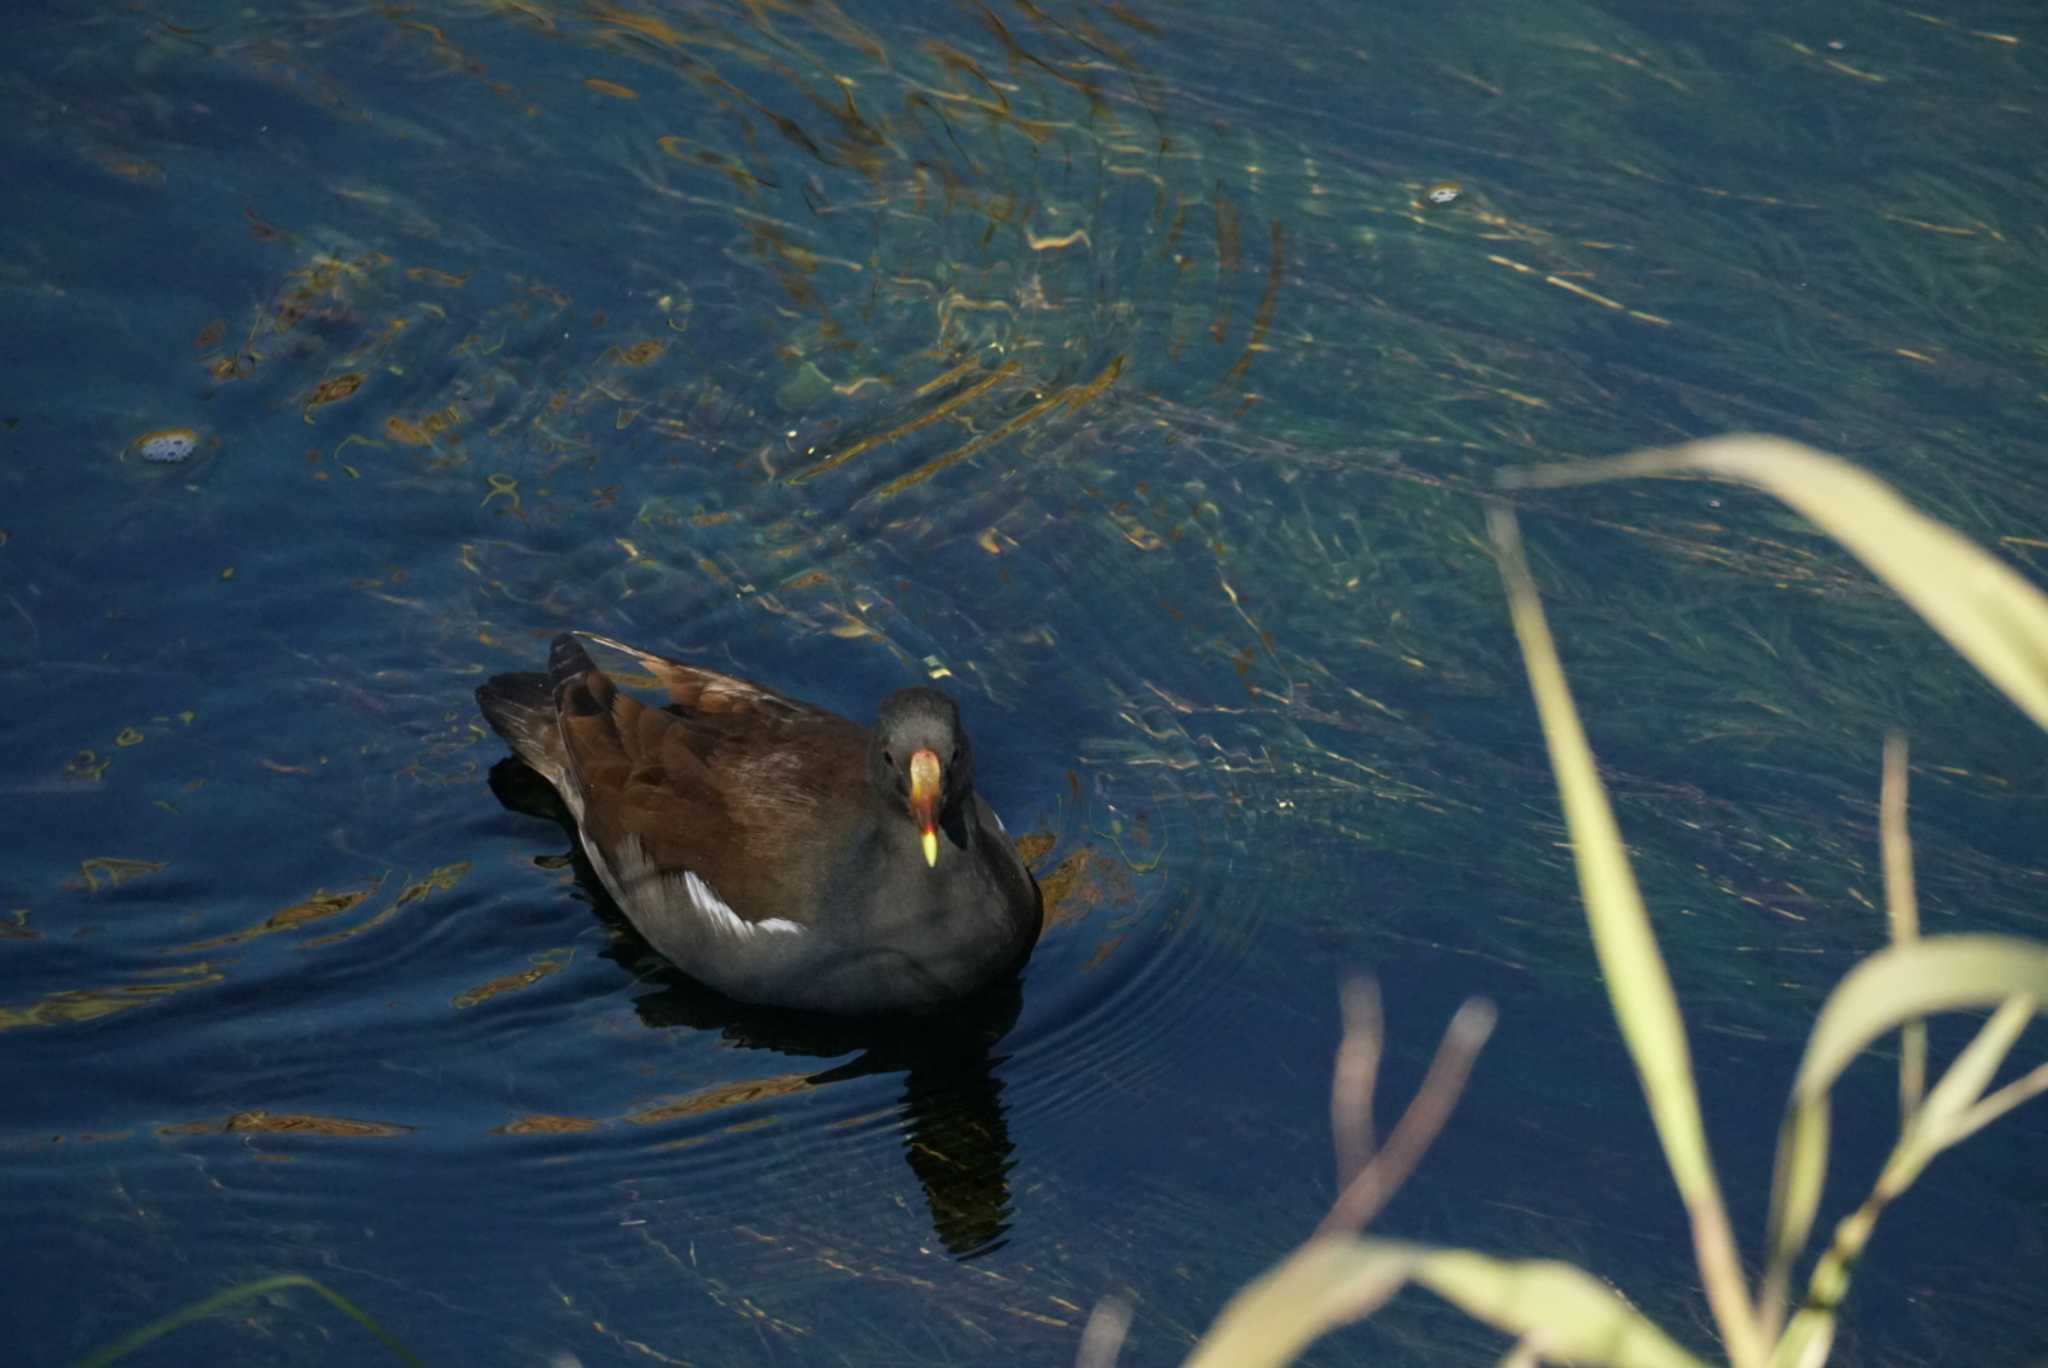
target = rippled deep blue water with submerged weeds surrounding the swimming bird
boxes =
[0,0,2048,1364]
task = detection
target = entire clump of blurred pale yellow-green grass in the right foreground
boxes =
[1114,436,2048,1368]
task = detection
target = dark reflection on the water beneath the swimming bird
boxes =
[489,758,1024,1259]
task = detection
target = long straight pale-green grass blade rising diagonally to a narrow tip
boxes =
[1487,506,1767,1368]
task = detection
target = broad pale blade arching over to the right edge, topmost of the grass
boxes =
[1503,436,2048,727]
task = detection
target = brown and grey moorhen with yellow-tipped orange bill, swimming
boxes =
[477,633,1044,1014]
